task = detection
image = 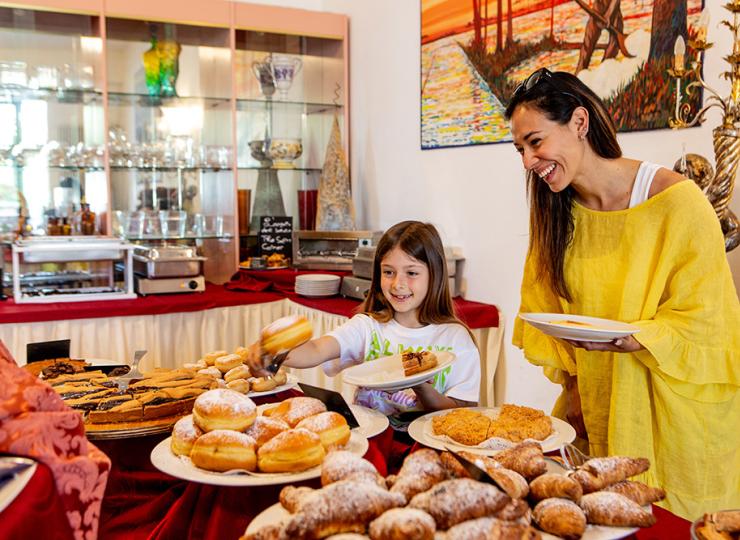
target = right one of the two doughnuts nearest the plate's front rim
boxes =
[258,429,326,472]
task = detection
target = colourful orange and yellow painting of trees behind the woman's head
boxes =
[421,0,702,149]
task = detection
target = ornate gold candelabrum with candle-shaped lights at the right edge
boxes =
[667,6,740,251]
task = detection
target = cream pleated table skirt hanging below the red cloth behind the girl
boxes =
[0,299,504,406]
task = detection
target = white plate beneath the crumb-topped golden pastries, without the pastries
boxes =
[409,407,576,456]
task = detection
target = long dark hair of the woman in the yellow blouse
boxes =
[505,71,622,301]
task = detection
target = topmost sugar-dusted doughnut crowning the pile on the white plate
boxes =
[193,388,257,431]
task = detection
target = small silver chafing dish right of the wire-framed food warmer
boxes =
[134,245,206,279]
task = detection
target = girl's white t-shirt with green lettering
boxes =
[323,313,480,414]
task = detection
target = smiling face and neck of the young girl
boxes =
[380,246,429,328]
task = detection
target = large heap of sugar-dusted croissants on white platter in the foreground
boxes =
[241,441,665,540]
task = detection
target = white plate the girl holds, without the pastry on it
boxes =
[342,351,455,390]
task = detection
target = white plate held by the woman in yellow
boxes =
[519,313,640,342]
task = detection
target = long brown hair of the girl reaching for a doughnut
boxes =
[360,221,475,342]
